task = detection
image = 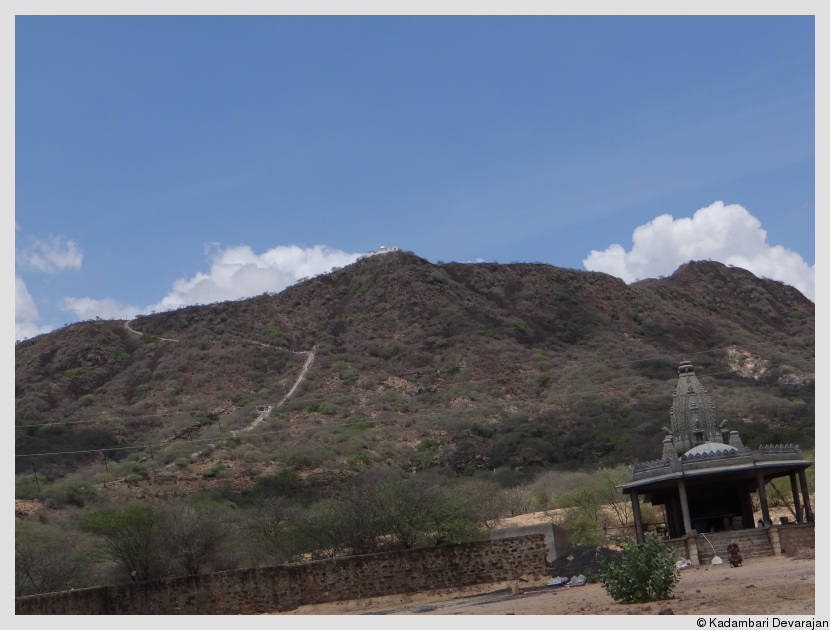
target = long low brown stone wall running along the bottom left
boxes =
[15,534,547,615]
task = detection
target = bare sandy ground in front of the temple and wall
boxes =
[283,556,816,616]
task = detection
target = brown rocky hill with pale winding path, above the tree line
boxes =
[15,252,815,494]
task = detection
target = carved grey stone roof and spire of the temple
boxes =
[620,361,812,493]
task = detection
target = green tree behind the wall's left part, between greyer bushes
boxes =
[78,503,165,580]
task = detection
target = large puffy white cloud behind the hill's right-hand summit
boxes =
[582,201,816,300]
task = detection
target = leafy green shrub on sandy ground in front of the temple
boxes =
[600,533,680,604]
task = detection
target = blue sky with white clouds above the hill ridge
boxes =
[14,15,815,339]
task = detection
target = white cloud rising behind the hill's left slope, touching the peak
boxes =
[55,245,360,326]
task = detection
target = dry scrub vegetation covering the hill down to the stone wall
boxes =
[15,252,815,593]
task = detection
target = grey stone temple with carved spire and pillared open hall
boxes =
[620,361,813,559]
